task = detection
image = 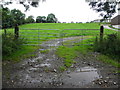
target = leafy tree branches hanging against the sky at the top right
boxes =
[86,0,120,21]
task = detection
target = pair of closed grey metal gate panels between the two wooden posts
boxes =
[19,29,100,46]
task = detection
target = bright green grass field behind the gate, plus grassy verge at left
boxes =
[0,23,116,59]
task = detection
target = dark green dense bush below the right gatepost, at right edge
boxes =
[94,34,120,58]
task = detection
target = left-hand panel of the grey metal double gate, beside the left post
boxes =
[19,29,60,46]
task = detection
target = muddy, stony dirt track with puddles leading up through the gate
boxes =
[3,37,118,88]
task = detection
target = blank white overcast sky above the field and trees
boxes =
[5,0,118,22]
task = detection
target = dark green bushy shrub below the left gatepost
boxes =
[2,33,25,58]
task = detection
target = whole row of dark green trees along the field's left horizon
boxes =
[0,7,58,29]
